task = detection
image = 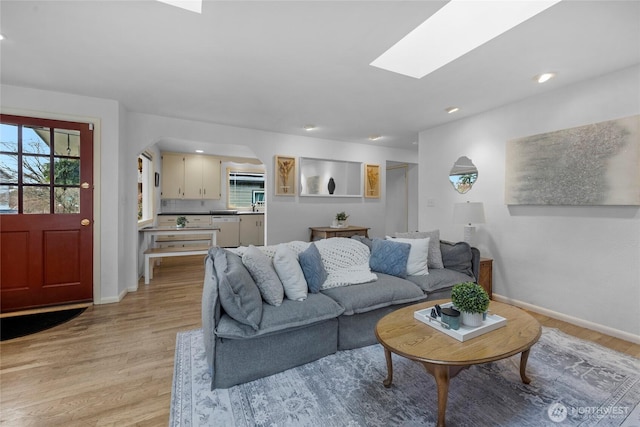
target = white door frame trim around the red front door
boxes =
[0,107,102,304]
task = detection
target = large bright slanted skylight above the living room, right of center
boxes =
[370,0,560,79]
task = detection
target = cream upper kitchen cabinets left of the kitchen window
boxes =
[161,153,221,200]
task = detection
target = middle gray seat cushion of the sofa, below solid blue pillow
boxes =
[322,273,427,315]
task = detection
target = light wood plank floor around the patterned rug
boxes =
[0,256,640,427]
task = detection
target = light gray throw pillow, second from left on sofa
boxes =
[242,245,284,306]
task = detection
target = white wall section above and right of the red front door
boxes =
[0,85,122,304]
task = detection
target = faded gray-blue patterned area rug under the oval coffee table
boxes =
[169,328,640,427]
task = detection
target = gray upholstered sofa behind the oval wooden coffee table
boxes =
[202,235,480,389]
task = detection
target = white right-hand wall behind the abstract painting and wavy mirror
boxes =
[419,66,640,342]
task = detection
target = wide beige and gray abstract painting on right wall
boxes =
[505,115,640,206]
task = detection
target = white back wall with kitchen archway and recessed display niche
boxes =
[127,113,415,245]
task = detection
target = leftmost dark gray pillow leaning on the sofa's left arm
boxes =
[213,248,262,331]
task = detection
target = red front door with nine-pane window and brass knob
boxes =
[0,115,93,313]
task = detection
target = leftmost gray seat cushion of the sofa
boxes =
[216,293,344,339]
